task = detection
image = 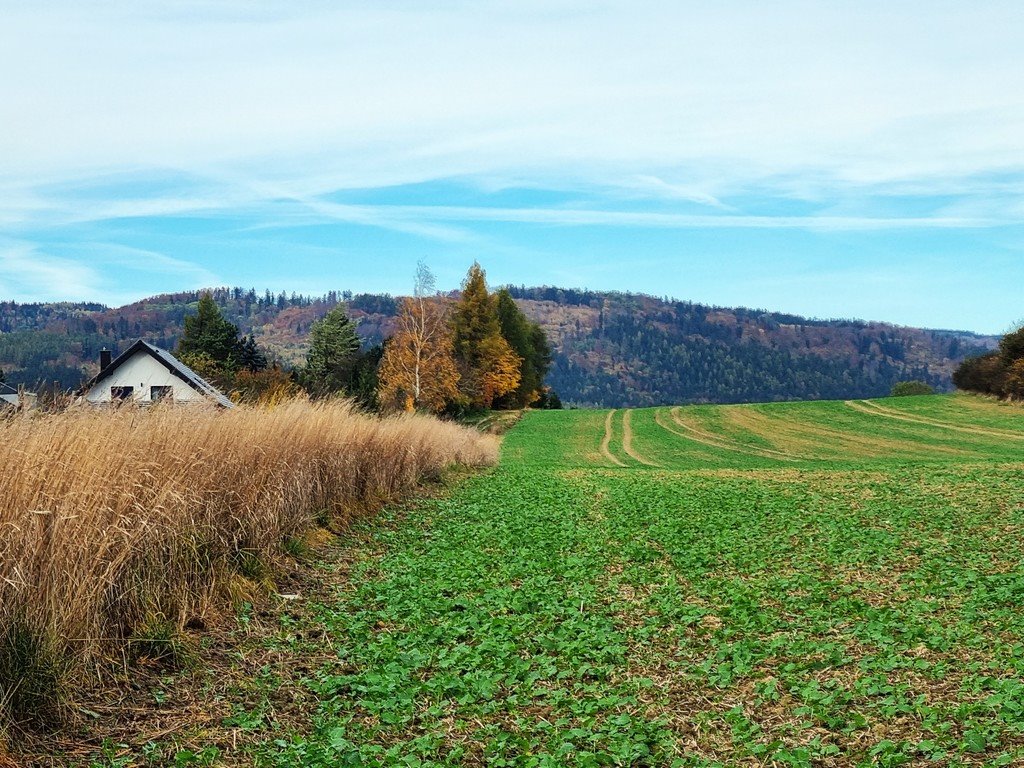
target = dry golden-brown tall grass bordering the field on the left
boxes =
[0,401,497,719]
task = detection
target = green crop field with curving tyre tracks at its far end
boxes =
[243,396,1024,768]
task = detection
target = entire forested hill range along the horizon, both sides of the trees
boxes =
[0,288,997,407]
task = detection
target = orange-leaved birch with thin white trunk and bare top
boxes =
[378,262,460,413]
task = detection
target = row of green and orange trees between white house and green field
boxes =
[175,263,561,415]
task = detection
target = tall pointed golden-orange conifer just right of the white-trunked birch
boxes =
[452,262,522,408]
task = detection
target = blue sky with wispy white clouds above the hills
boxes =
[0,0,1024,333]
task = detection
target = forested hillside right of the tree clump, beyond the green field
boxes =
[510,288,997,407]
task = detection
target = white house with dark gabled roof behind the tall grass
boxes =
[81,339,234,408]
